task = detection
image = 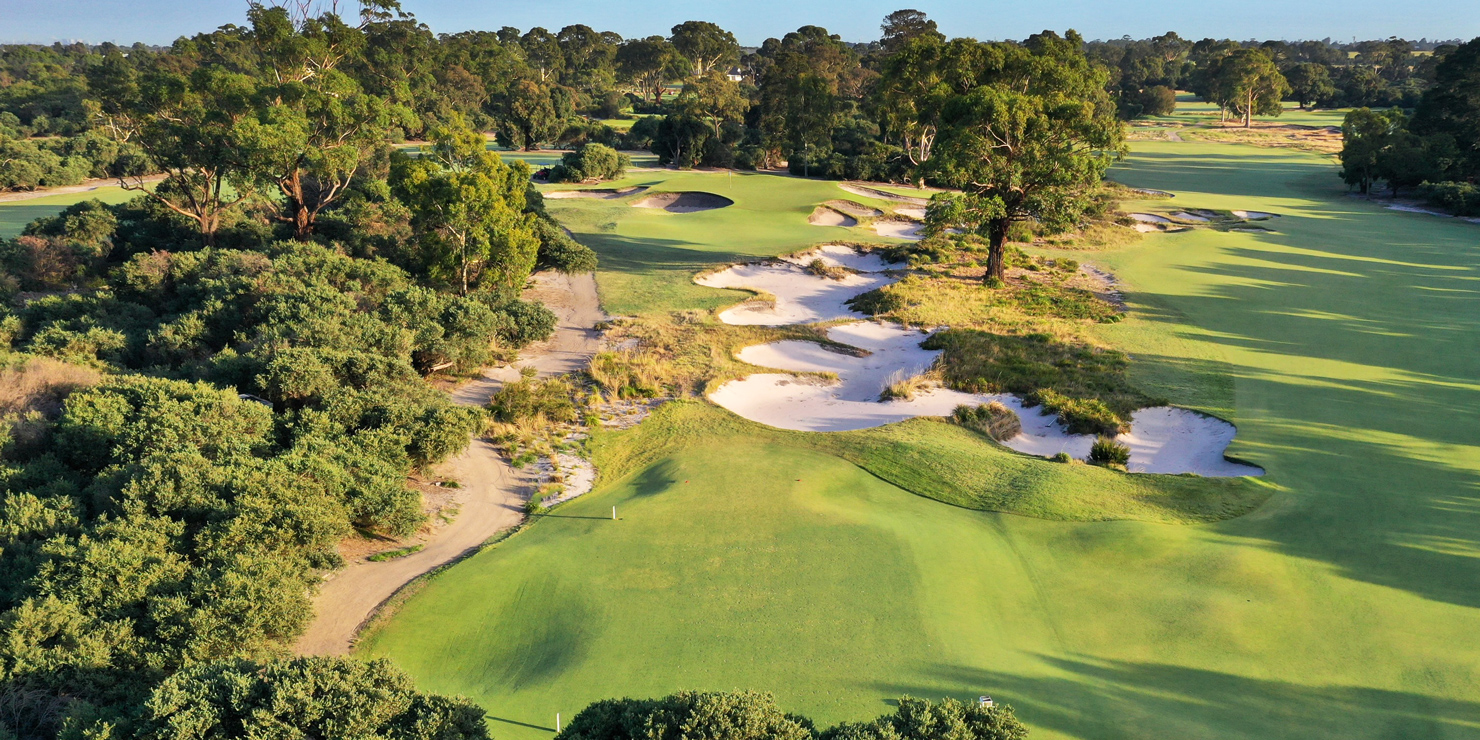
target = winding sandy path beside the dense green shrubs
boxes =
[293,272,605,656]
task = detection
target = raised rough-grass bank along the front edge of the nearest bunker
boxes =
[592,401,1270,524]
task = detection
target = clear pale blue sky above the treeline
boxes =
[0,0,1480,44]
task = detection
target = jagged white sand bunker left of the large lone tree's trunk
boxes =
[694,246,898,326]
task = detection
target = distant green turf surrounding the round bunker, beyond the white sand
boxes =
[543,170,892,315]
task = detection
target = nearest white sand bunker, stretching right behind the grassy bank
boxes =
[709,321,1264,477]
